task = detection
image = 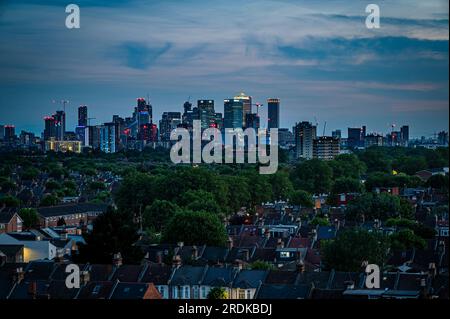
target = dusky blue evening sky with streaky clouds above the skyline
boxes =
[0,0,449,137]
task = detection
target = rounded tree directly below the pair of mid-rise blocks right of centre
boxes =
[292,159,333,194]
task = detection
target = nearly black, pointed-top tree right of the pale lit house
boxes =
[75,207,144,264]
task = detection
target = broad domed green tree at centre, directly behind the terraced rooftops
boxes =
[162,211,227,246]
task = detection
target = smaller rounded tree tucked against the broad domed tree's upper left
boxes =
[143,199,180,232]
